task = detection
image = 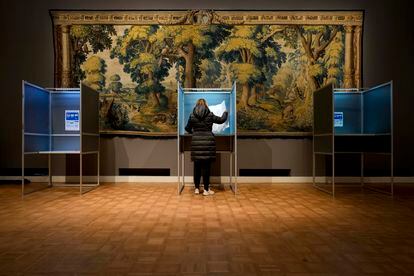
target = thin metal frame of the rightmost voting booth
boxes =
[312,81,394,197]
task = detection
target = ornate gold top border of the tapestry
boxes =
[51,10,363,26]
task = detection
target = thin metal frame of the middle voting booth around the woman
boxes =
[177,82,238,195]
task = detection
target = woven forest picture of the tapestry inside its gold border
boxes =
[71,25,344,133]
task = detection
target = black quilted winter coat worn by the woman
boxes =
[185,105,227,161]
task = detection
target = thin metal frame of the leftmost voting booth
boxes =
[21,80,100,197]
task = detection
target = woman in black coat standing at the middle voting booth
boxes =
[185,99,228,196]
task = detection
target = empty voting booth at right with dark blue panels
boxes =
[313,82,394,195]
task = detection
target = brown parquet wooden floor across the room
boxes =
[0,184,414,275]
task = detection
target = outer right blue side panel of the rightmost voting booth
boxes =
[364,83,392,134]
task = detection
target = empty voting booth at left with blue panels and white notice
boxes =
[22,81,99,195]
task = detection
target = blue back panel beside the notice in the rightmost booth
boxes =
[334,92,362,134]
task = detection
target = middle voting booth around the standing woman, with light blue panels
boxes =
[177,83,237,194]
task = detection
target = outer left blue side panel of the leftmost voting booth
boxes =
[23,83,50,134]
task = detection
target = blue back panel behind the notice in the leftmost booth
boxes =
[51,91,80,134]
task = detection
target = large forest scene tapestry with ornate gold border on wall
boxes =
[51,11,363,136]
